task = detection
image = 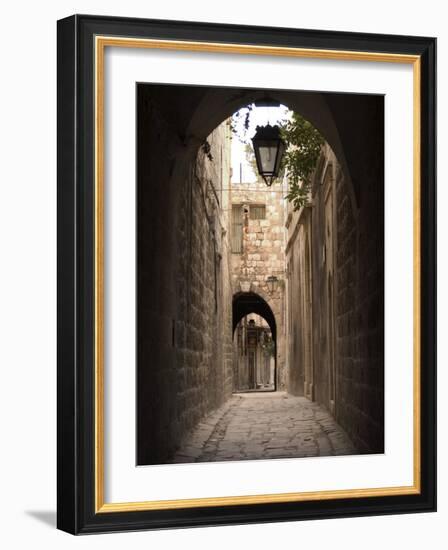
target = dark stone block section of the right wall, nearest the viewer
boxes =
[336,136,385,452]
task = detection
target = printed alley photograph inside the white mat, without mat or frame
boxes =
[137,83,384,465]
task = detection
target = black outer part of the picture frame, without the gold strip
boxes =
[57,15,436,534]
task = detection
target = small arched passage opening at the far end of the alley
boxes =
[232,292,277,391]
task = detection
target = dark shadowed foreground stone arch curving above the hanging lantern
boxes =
[139,84,384,216]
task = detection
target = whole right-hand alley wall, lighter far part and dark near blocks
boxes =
[286,140,384,452]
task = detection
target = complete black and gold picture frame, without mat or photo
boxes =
[57,15,436,534]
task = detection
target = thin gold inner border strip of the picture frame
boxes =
[94,36,421,513]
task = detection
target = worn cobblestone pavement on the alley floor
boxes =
[170,392,357,463]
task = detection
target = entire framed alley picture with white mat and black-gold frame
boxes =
[58,15,436,534]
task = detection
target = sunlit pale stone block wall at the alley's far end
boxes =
[232,182,286,390]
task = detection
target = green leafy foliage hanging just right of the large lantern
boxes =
[280,113,324,210]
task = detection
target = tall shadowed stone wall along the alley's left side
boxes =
[137,87,232,464]
